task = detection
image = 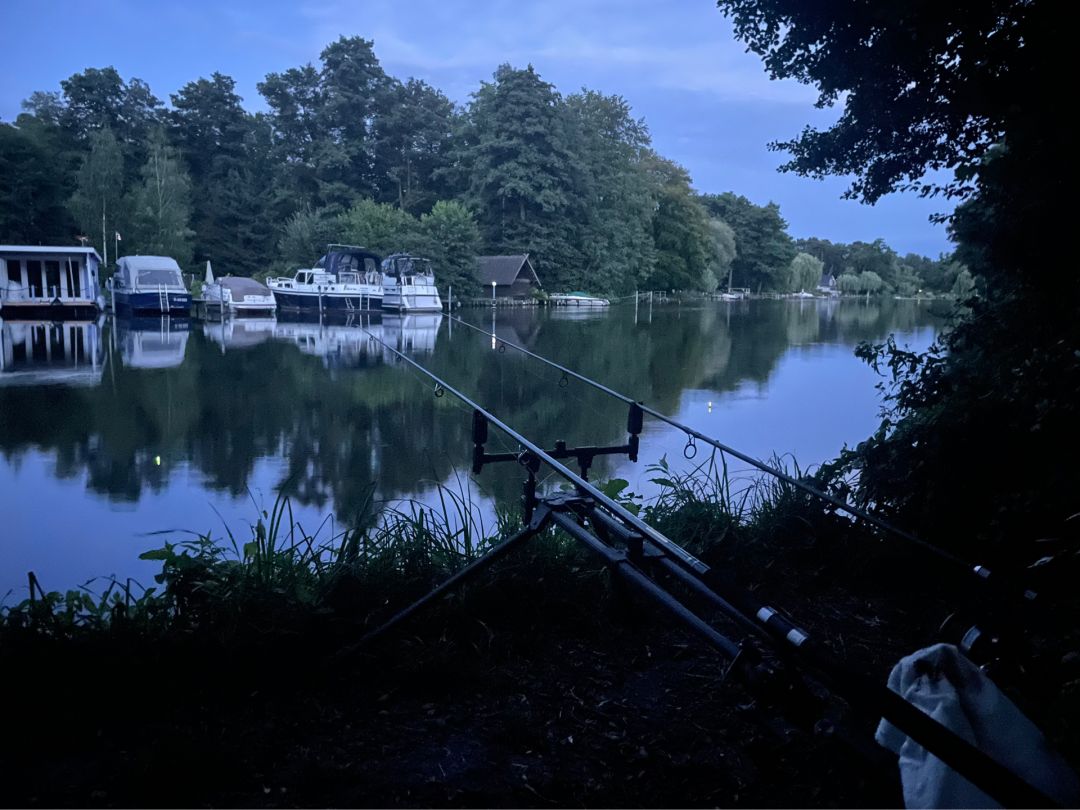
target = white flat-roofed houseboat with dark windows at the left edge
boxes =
[0,245,105,321]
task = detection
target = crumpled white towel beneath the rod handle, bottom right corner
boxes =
[876,644,1080,808]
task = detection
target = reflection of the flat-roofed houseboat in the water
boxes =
[0,318,105,386]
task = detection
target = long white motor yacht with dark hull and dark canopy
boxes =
[267,244,382,314]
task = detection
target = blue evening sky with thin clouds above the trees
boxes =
[0,0,949,256]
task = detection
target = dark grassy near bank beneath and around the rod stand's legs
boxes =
[0,463,1071,806]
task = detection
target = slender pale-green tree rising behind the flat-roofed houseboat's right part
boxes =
[71,127,127,261]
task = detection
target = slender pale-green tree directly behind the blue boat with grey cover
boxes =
[129,132,194,267]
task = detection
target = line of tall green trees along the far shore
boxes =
[0,37,962,295]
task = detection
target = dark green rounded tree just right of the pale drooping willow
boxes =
[701,191,796,292]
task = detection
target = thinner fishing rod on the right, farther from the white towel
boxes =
[449,314,1038,602]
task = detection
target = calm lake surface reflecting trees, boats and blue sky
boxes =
[0,300,941,604]
